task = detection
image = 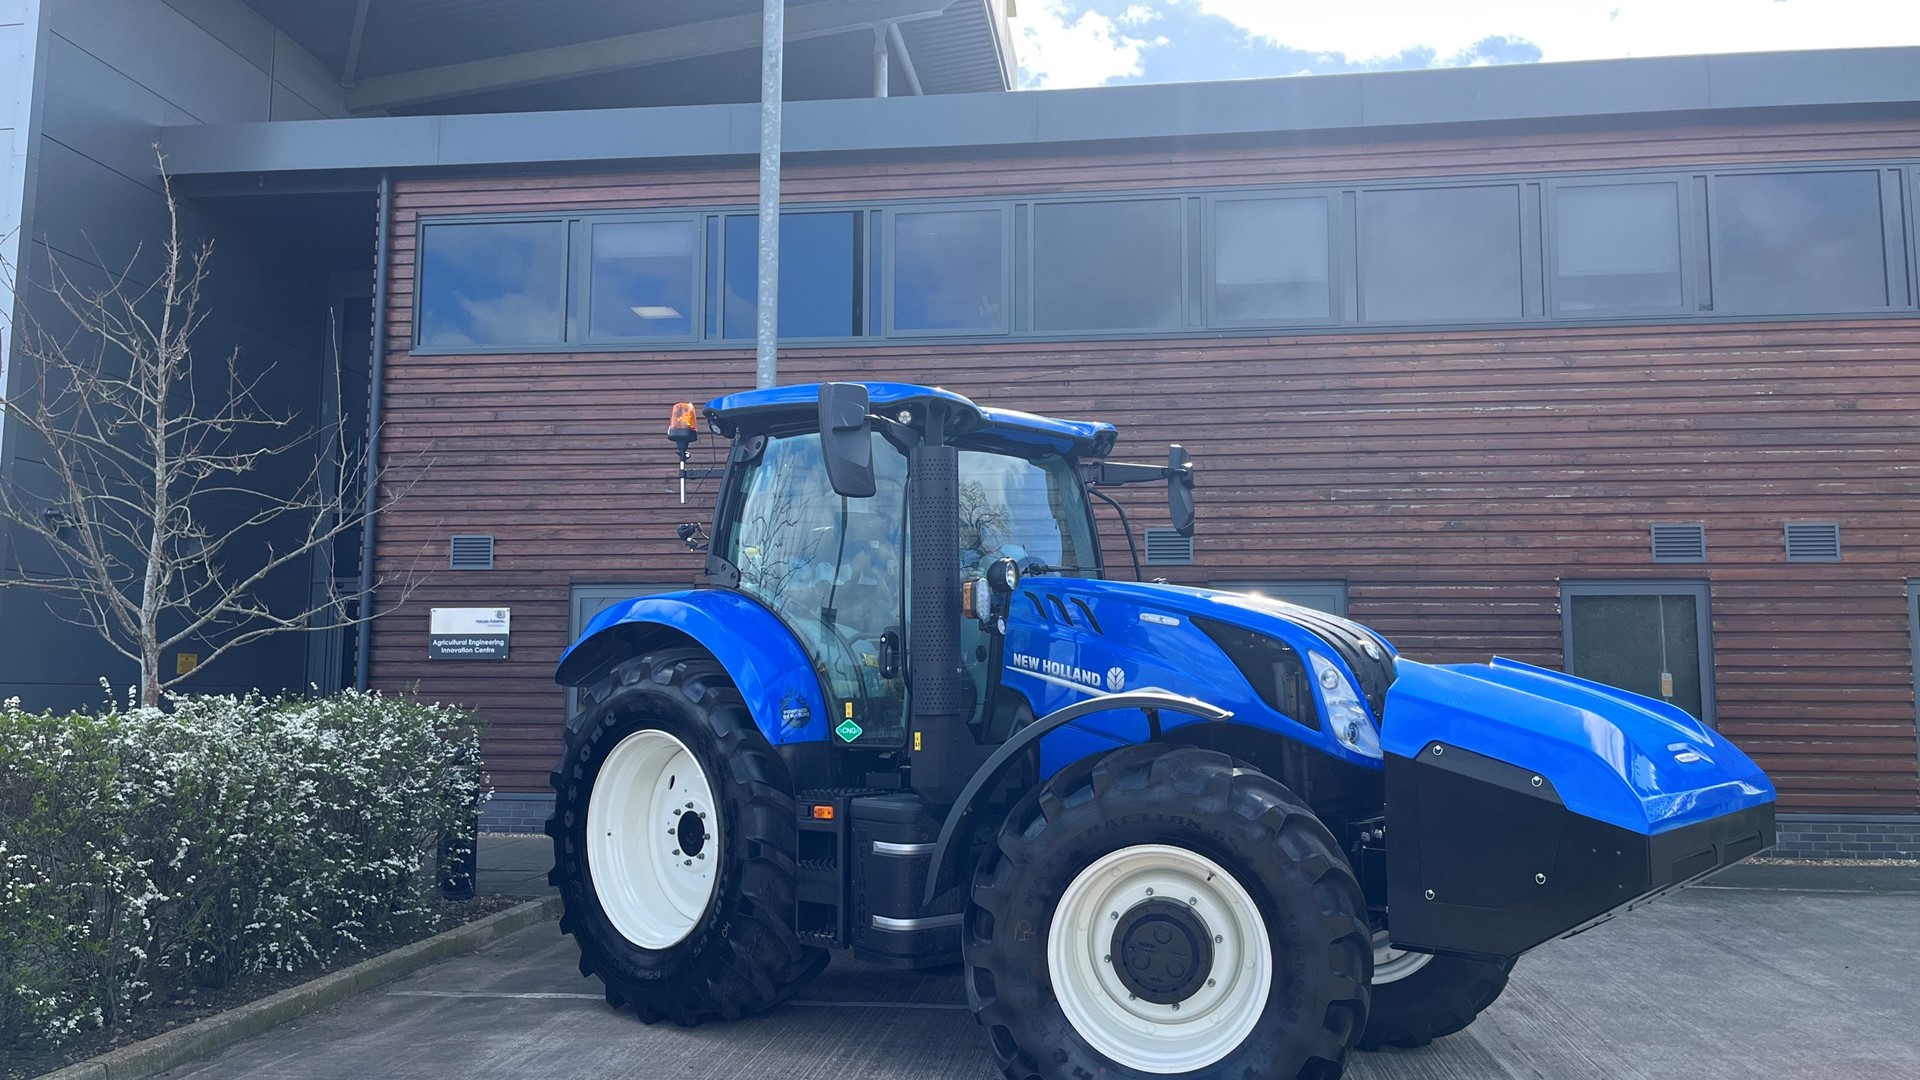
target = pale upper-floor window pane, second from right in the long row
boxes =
[1553,183,1686,317]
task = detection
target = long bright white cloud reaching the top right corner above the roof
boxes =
[1190,0,1920,61]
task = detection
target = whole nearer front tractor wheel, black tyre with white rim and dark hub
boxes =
[962,744,1373,1080]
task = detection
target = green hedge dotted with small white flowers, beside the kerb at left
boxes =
[0,692,482,1049]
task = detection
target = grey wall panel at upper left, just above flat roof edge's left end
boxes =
[46,0,269,123]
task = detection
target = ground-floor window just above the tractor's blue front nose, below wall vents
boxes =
[1561,582,1715,724]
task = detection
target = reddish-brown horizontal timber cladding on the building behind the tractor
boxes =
[371,121,1920,813]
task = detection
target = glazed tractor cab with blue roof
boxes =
[707,382,1116,749]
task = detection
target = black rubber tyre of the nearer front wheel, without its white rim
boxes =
[962,744,1373,1080]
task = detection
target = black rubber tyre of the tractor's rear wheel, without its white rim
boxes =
[547,650,828,1026]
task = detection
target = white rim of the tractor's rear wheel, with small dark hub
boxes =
[588,730,722,949]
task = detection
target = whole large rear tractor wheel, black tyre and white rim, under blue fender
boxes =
[547,650,828,1024]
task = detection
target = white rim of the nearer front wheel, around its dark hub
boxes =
[1046,844,1273,1074]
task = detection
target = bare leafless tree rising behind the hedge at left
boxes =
[0,161,411,705]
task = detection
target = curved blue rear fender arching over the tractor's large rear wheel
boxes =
[553,588,829,746]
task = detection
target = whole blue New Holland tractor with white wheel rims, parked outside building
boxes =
[547,382,1774,1080]
